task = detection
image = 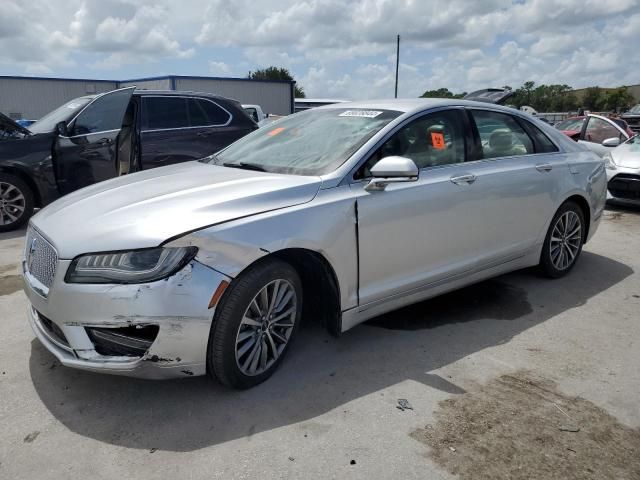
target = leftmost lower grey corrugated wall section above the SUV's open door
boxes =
[0,77,117,120]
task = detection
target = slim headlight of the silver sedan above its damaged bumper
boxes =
[65,247,198,283]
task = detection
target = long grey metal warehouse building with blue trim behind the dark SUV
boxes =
[0,75,295,120]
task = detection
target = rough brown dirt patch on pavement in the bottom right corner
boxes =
[412,371,640,480]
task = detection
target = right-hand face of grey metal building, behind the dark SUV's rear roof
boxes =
[175,77,292,115]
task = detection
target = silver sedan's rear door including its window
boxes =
[465,108,568,260]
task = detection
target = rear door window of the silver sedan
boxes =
[470,110,535,158]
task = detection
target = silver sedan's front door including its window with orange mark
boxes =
[352,109,480,305]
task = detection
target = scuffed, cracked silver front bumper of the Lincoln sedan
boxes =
[22,260,230,379]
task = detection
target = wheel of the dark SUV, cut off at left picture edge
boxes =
[0,173,34,232]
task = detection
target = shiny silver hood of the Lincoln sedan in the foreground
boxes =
[31,162,322,259]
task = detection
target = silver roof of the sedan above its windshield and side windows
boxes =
[317,98,523,114]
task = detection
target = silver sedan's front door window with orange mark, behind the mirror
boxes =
[355,110,465,179]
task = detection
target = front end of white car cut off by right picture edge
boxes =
[603,135,640,205]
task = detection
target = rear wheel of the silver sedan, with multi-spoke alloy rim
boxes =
[540,201,586,278]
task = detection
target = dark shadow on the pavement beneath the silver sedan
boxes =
[30,252,633,451]
